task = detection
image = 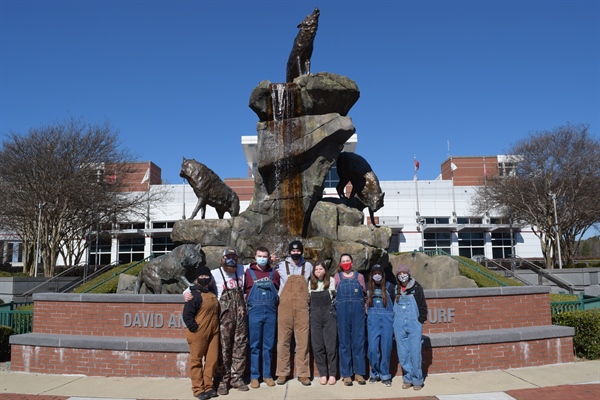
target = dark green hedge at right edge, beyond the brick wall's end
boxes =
[552,308,600,360]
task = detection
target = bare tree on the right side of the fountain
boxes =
[473,124,600,269]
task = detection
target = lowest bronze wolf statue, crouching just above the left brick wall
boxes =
[135,244,206,294]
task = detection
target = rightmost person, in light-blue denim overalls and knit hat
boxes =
[394,264,427,390]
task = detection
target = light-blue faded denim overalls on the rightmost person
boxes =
[394,288,423,386]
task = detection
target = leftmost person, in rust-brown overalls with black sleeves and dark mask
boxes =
[182,265,219,400]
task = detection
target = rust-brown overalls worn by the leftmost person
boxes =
[186,292,219,397]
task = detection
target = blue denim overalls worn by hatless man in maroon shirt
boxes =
[247,269,278,379]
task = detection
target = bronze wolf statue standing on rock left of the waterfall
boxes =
[179,157,240,219]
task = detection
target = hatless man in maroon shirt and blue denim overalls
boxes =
[244,247,279,389]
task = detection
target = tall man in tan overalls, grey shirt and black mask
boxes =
[277,240,313,386]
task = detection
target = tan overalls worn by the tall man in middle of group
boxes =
[277,262,310,378]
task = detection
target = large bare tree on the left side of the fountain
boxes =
[0,119,164,276]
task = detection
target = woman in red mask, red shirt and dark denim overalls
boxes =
[334,254,367,386]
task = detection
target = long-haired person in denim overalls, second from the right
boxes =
[367,264,394,386]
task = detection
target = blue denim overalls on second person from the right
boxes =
[367,282,394,381]
